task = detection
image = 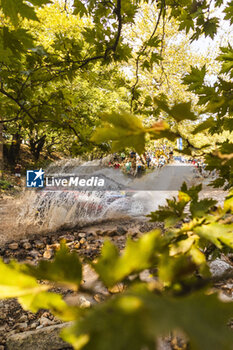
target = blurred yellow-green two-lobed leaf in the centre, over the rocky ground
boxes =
[93,230,160,287]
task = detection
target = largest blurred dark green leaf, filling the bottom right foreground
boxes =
[62,290,233,350]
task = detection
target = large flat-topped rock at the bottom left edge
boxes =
[6,323,71,350]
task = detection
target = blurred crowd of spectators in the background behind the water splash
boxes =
[109,145,173,176]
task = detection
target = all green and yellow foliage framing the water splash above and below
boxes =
[0,0,233,350]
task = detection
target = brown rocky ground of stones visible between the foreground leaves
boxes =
[0,194,233,350]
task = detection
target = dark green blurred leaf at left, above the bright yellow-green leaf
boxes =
[24,243,82,289]
